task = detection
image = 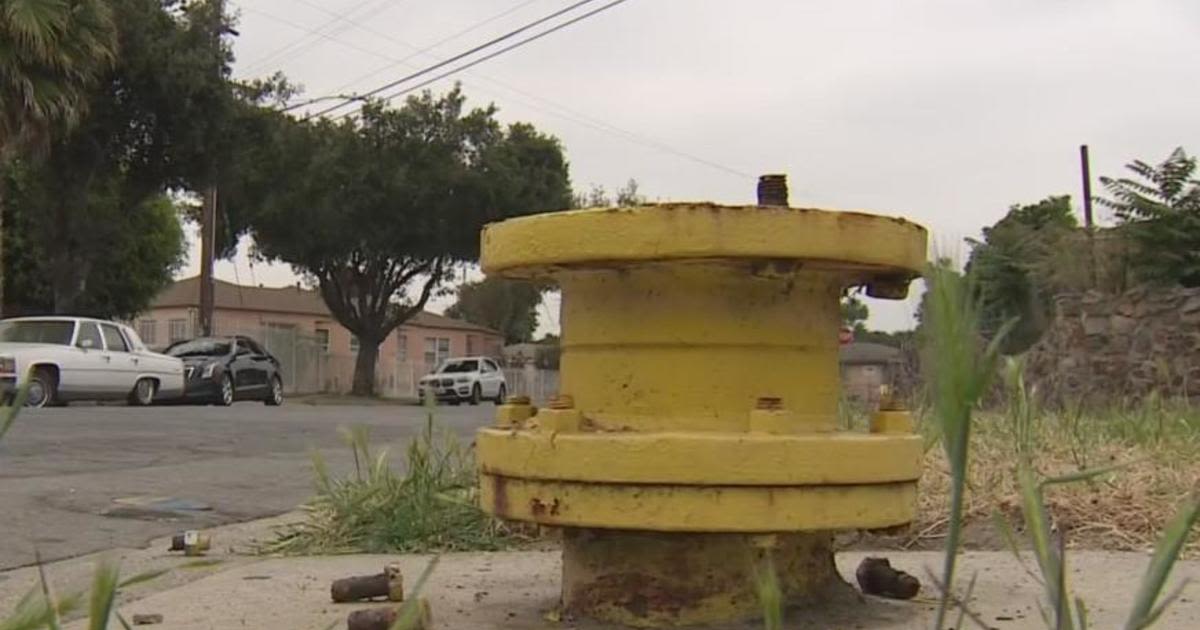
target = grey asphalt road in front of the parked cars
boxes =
[0,402,493,570]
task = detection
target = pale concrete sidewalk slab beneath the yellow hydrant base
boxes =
[70,551,1200,630]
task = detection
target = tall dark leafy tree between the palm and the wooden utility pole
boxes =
[10,0,233,312]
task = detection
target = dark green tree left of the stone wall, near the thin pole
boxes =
[966,194,1078,354]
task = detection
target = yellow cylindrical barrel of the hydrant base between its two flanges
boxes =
[557,262,841,432]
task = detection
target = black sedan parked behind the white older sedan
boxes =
[166,336,283,407]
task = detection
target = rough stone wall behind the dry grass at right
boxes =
[1028,288,1200,403]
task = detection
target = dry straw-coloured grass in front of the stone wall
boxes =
[907,401,1200,558]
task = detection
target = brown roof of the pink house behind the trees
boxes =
[150,276,499,335]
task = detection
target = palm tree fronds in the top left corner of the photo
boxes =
[0,0,116,314]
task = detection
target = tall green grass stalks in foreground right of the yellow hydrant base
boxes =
[924,266,1200,630]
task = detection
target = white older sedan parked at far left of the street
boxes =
[0,317,184,407]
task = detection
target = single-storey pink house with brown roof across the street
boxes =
[131,277,504,396]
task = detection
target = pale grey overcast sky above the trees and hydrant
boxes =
[177,0,1200,329]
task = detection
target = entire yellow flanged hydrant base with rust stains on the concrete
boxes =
[476,175,926,626]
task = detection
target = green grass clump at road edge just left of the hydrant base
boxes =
[264,414,510,553]
